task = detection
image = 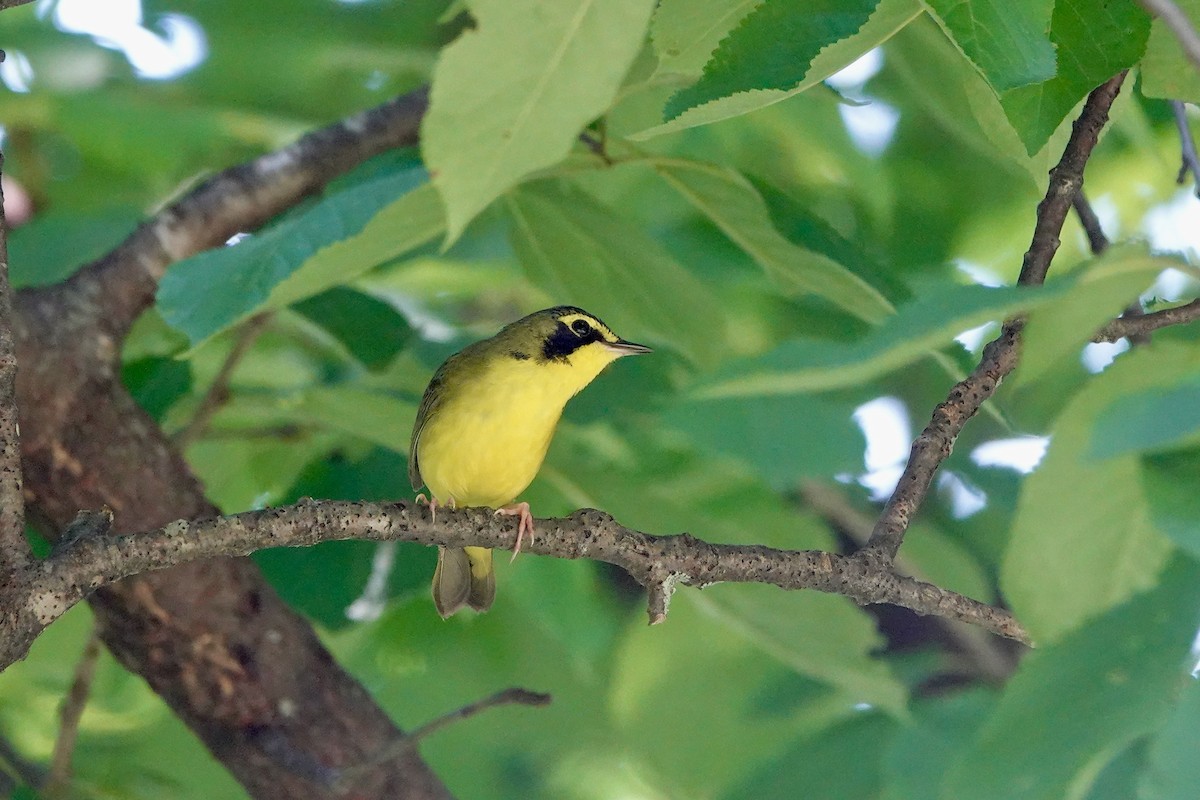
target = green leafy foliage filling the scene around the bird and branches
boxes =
[0,0,1200,800]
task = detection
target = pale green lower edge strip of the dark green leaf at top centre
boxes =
[629,0,924,142]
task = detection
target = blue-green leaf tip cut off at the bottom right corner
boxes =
[1138,678,1200,800]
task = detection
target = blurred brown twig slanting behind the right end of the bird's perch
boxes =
[800,481,1016,684]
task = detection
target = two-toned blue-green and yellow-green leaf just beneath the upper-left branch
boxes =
[158,169,442,345]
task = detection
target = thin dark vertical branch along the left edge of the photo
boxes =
[0,154,31,587]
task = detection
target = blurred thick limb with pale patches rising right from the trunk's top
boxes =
[68,89,428,339]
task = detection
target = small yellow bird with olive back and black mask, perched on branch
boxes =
[408,306,652,619]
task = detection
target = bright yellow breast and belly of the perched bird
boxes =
[418,361,575,509]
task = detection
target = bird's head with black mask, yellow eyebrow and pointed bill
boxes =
[496,306,650,389]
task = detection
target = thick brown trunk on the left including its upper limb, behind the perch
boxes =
[10,86,450,800]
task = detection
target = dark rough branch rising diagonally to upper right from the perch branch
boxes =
[860,72,1126,564]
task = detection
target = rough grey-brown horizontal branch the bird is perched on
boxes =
[0,500,1030,666]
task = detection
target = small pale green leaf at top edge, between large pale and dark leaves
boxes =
[650,0,762,78]
